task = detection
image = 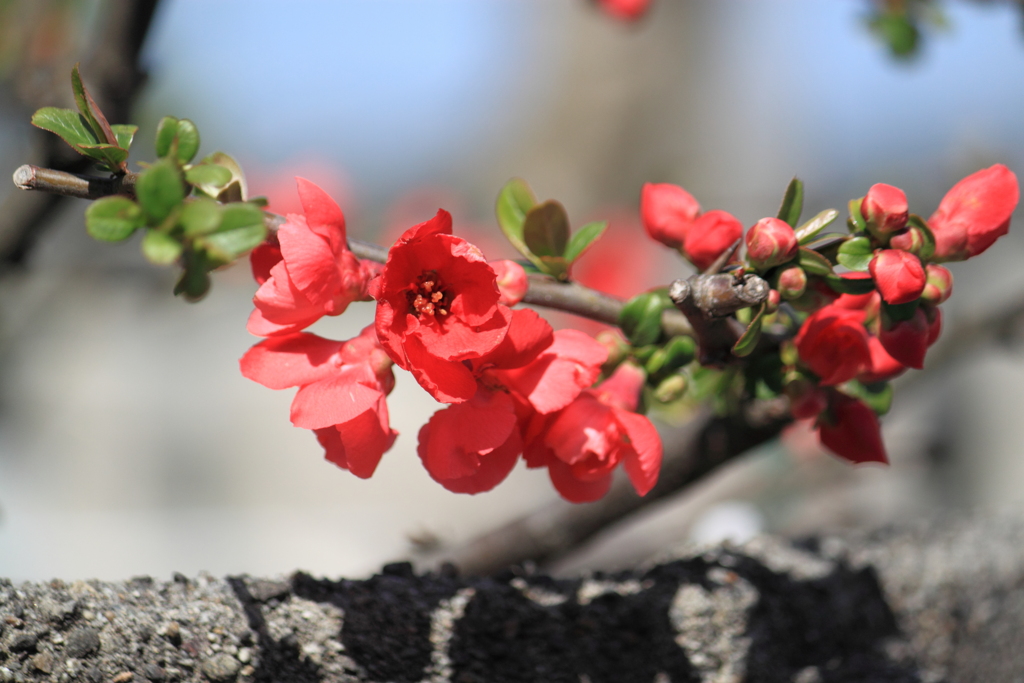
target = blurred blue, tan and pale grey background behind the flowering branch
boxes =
[0,0,1024,581]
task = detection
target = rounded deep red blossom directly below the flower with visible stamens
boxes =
[417,388,522,494]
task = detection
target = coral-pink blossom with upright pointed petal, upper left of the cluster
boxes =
[248,178,376,337]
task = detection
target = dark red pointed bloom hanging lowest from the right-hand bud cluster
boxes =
[818,391,889,465]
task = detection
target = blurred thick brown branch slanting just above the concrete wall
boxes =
[427,402,791,574]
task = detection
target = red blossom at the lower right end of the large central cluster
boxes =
[530,364,662,503]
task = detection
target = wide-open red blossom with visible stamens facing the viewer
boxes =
[374,210,512,403]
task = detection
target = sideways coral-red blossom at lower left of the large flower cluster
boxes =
[240,327,397,478]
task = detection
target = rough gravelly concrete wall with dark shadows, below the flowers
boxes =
[0,520,1024,683]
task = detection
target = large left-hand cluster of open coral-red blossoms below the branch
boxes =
[241,179,662,502]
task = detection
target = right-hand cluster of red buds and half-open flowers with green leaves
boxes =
[641,165,1019,463]
